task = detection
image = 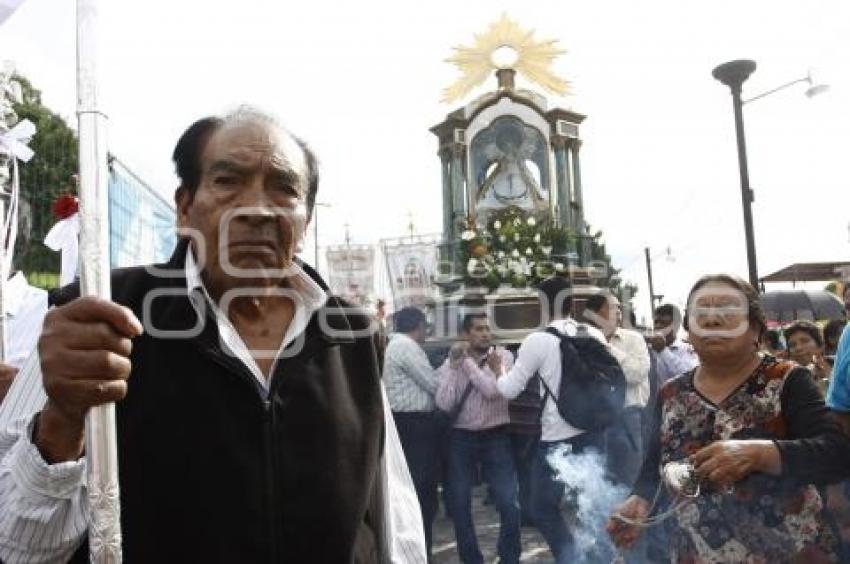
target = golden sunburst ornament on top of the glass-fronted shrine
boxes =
[443,14,569,102]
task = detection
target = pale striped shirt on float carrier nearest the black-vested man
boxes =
[384,333,437,413]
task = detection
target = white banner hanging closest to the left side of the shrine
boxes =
[384,239,438,311]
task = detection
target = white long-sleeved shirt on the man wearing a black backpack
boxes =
[496,318,610,441]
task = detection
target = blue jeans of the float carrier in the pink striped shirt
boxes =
[448,427,522,564]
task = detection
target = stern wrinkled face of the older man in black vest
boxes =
[177,121,307,292]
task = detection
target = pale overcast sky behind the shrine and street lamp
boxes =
[0,0,850,322]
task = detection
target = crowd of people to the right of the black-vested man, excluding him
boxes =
[384,275,850,564]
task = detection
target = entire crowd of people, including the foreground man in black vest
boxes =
[0,104,850,564]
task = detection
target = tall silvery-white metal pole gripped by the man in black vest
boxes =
[77,0,121,564]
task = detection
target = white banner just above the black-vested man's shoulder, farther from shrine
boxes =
[327,246,375,305]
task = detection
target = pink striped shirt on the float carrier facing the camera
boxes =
[437,347,514,431]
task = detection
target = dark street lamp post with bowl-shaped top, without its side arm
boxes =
[711,59,759,289]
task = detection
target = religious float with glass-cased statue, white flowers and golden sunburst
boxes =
[423,15,628,346]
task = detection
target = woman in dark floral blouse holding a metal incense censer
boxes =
[608,274,850,563]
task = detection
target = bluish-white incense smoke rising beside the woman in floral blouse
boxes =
[546,445,629,562]
